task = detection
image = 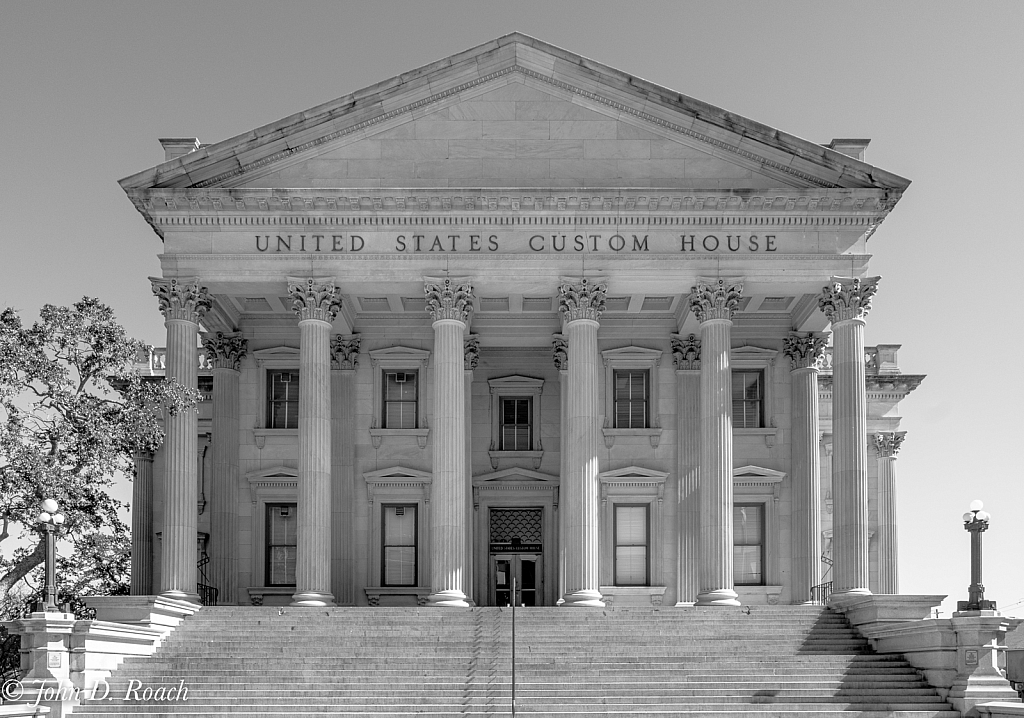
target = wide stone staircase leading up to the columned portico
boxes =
[75,606,959,718]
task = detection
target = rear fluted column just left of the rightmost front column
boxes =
[782,332,825,603]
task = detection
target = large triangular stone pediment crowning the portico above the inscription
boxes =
[116,33,908,193]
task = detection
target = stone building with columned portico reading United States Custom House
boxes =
[121,34,922,606]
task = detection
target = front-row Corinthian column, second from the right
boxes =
[689,280,743,605]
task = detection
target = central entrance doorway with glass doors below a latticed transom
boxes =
[488,508,544,606]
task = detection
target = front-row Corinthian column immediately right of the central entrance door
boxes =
[558,278,607,607]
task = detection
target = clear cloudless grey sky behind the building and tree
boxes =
[0,0,1024,616]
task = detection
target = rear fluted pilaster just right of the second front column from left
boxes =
[331,334,359,605]
